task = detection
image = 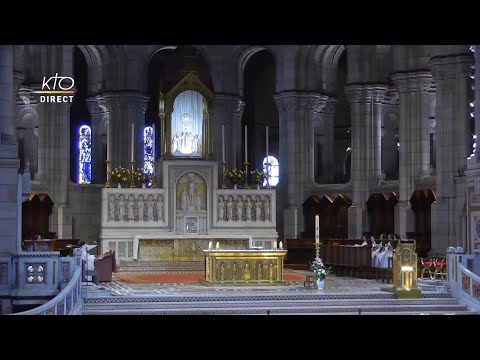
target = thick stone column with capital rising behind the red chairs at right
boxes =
[429,55,474,254]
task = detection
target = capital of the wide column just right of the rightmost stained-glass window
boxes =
[273,91,328,113]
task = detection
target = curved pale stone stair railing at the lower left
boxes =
[13,247,83,315]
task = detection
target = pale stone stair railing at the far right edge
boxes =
[447,254,480,311]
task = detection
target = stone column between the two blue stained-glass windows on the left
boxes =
[103,92,148,169]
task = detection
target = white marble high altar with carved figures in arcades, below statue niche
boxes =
[100,159,278,260]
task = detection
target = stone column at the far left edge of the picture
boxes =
[0,45,21,255]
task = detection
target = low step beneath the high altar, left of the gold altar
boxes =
[117,261,205,273]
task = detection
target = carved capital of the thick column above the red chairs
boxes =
[428,54,474,81]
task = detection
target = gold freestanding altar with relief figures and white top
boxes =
[203,249,287,285]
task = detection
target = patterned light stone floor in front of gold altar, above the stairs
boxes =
[97,271,398,296]
